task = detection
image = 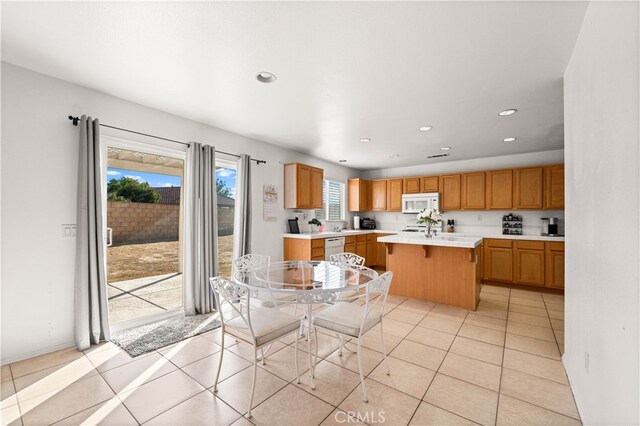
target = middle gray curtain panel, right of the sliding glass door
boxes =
[184,142,218,315]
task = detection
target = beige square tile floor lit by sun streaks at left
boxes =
[2,286,580,425]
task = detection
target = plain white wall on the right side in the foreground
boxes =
[563,2,640,425]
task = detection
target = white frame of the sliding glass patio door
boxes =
[100,135,187,333]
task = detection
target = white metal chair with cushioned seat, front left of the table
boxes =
[209,277,300,418]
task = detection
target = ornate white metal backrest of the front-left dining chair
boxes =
[209,277,255,338]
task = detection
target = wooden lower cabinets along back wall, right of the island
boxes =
[482,238,564,289]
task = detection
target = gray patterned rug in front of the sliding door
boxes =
[111,313,220,357]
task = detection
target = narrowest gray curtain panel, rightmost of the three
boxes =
[233,154,251,259]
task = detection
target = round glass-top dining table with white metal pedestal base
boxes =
[243,260,378,389]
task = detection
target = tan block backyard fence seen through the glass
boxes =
[107,201,234,246]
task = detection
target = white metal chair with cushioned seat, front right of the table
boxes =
[313,272,393,402]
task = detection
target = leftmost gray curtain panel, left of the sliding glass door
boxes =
[74,115,111,350]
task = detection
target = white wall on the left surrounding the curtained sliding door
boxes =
[1,62,357,364]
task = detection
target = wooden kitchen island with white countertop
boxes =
[378,233,482,310]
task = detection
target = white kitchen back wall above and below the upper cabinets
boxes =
[361,150,564,235]
